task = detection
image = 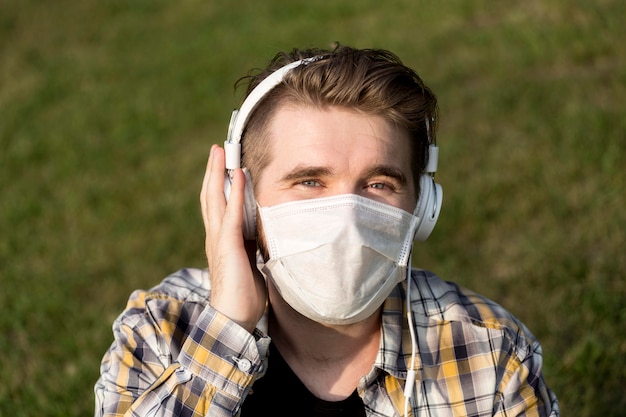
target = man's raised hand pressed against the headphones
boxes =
[200,145,267,333]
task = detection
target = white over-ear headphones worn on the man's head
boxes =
[224,56,443,241]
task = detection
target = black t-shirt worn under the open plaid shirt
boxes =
[241,344,365,417]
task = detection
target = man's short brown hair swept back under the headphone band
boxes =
[238,46,437,195]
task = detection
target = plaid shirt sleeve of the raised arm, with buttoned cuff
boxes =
[95,292,269,417]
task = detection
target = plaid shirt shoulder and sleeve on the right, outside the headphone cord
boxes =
[402,271,560,417]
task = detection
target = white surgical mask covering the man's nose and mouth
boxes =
[259,194,418,324]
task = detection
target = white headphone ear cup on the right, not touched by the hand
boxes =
[413,174,443,242]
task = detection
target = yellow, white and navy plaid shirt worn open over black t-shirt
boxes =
[95,269,559,417]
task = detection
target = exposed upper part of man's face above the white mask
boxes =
[255,106,416,213]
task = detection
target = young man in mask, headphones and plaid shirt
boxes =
[96,47,559,416]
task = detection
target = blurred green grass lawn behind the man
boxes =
[0,0,626,417]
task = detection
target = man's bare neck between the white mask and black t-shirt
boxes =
[269,286,380,401]
